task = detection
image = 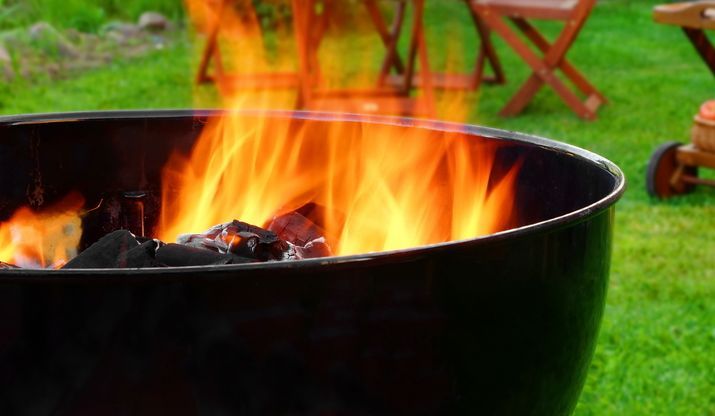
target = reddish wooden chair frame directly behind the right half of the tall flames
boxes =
[293,0,435,116]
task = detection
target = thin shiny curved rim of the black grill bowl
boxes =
[0,109,626,281]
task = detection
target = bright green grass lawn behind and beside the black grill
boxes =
[0,0,715,415]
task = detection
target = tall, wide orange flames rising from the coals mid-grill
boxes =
[159,1,519,255]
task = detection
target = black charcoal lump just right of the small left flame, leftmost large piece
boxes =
[62,230,139,269]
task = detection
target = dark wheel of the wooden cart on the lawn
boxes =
[646,142,698,199]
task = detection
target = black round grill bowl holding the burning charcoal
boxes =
[0,111,624,415]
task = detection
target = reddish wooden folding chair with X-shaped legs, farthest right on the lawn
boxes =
[470,0,606,120]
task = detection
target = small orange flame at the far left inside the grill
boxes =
[0,193,84,268]
